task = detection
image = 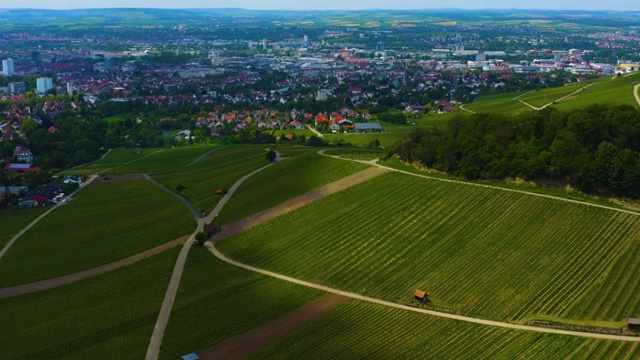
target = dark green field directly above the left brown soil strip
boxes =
[0,180,195,287]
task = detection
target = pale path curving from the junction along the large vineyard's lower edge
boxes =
[205,242,640,342]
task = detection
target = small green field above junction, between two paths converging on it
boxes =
[155,147,268,210]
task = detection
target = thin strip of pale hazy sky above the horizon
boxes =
[5,0,640,10]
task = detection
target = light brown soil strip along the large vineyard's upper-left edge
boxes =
[211,167,387,242]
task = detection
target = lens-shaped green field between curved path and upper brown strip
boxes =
[215,152,368,224]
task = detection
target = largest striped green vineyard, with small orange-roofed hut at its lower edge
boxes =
[220,173,640,326]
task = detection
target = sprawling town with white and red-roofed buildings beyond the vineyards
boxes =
[0,8,640,208]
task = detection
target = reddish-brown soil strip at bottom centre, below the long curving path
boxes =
[198,294,349,360]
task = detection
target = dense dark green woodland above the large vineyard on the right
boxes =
[394,104,640,198]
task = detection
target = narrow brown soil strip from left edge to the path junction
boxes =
[0,236,188,299]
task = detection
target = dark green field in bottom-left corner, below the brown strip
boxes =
[0,248,179,360]
